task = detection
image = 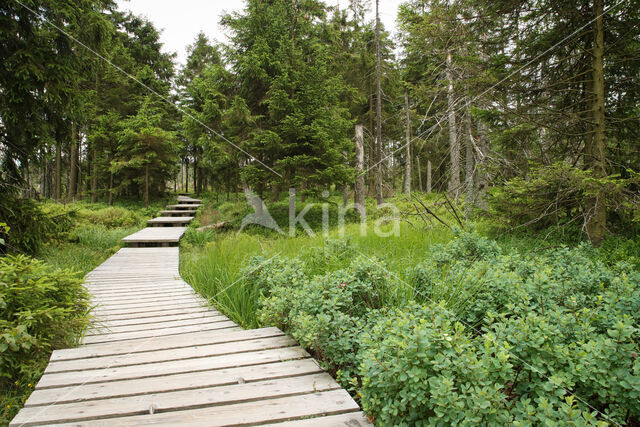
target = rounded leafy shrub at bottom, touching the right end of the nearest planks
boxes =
[360,304,511,425]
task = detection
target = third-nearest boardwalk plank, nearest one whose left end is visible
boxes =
[14,373,340,426]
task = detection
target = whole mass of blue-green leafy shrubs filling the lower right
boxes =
[245,232,640,425]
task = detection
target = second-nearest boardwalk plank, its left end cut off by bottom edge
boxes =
[50,390,359,427]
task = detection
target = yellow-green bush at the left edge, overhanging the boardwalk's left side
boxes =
[0,255,89,421]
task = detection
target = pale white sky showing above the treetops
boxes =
[117,0,401,64]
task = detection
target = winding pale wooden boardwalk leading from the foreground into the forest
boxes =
[10,197,370,426]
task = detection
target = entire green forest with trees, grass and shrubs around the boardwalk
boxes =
[0,0,640,426]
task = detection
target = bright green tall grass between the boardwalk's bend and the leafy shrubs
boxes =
[180,224,452,328]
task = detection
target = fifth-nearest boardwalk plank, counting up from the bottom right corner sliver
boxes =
[37,347,309,388]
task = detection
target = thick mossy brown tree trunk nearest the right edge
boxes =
[586,0,607,246]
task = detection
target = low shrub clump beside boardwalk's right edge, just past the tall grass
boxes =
[255,252,392,381]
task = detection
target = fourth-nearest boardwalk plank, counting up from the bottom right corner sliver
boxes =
[25,359,322,406]
